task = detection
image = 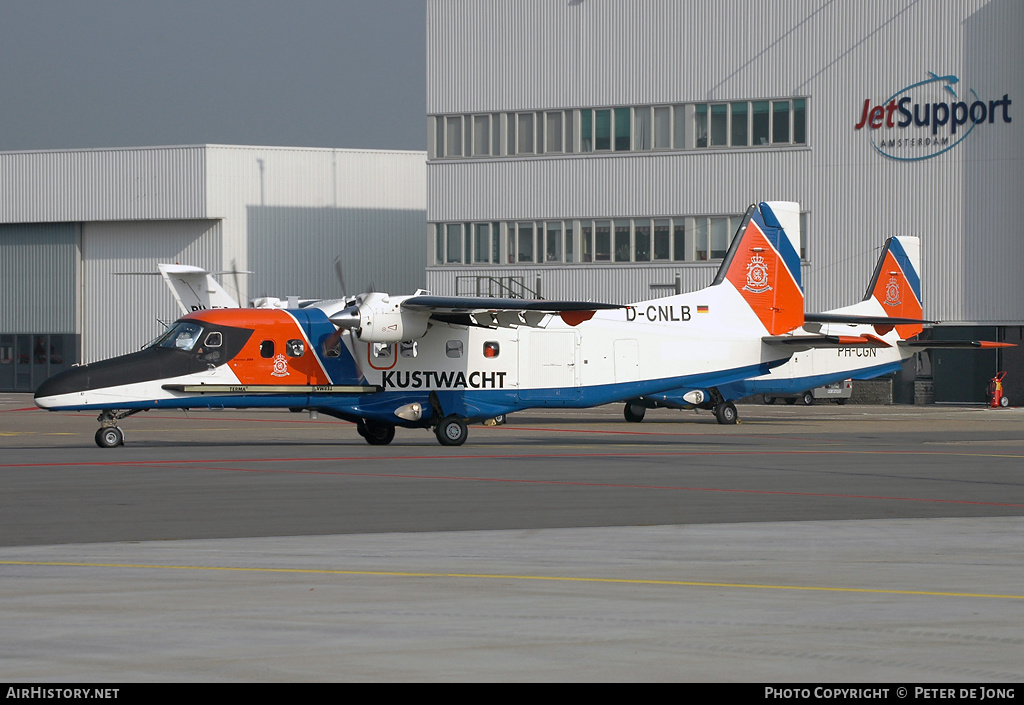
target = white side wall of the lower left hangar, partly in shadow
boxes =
[209,147,427,299]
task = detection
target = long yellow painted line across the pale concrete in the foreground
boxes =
[0,561,1024,599]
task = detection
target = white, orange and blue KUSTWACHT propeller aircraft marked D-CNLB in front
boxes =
[36,202,872,447]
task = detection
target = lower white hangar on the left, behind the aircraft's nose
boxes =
[0,144,426,391]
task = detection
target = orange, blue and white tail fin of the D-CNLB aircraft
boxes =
[713,201,804,335]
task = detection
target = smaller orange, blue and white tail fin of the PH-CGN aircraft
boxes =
[863,236,924,340]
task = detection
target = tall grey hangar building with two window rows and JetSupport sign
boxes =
[426,0,1024,402]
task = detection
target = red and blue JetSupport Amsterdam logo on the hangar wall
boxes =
[854,72,1013,162]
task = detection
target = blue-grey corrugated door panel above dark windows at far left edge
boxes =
[0,223,79,333]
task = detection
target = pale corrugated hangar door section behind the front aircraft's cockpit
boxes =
[82,220,221,363]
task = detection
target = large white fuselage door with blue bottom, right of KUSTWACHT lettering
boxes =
[519,328,582,401]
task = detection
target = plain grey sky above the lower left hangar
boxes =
[0,0,426,151]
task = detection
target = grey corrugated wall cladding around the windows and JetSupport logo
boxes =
[427,0,1024,323]
